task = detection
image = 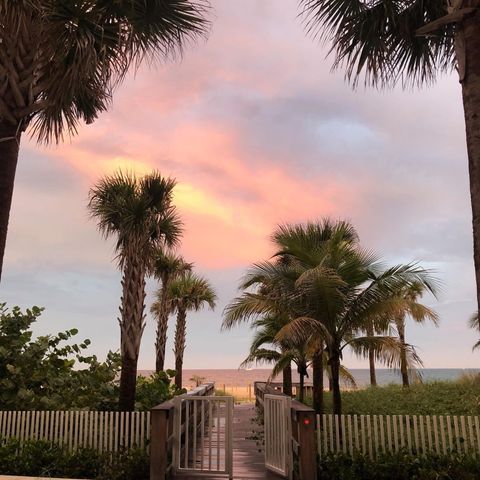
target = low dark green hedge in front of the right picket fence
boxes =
[318,452,480,480]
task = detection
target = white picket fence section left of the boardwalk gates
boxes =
[0,411,150,452]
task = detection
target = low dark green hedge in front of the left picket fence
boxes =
[0,439,150,480]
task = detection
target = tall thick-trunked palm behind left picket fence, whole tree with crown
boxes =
[88,172,181,410]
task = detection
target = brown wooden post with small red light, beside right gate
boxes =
[296,409,317,480]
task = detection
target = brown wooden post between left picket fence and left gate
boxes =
[150,407,170,480]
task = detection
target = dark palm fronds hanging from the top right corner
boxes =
[300,0,455,87]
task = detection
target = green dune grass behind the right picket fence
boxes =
[306,375,480,415]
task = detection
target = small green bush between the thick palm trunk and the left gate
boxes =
[135,370,186,410]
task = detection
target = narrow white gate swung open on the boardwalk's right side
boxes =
[263,395,292,479]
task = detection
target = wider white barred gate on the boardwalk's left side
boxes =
[173,396,233,479]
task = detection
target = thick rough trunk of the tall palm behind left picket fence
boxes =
[119,258,145,411]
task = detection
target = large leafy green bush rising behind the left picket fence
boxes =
[0,304,120,410]
